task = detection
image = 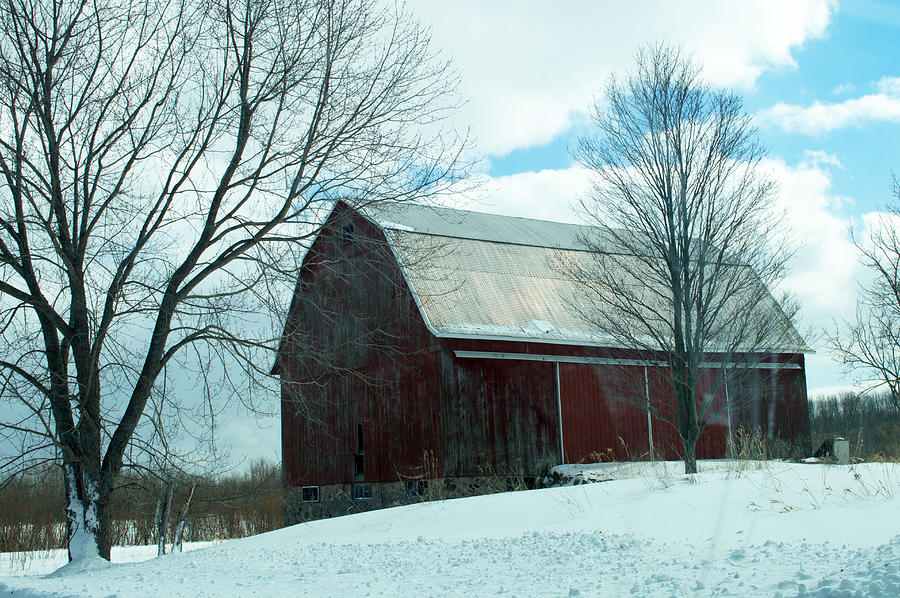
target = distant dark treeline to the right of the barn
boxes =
[809,392,900,461]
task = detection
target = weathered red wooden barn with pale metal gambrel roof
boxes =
[273,203,809,523]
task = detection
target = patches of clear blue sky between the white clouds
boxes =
[486,1,900,213]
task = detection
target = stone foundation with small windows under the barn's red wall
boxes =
[283,476,540,525]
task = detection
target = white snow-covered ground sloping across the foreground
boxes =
[0,461,900,598]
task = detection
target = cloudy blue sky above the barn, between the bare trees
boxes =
[225,0,900,466]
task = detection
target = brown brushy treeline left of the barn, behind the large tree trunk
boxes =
[0,461,283,552]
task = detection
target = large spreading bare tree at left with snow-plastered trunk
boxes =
[0,0,464,560]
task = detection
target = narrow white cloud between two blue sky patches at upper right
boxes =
[757,77,900,135]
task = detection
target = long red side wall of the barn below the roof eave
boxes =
[443,339,809,472]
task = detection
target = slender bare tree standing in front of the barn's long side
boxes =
[567,45,802,473]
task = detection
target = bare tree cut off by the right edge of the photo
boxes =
[829,178,900,411]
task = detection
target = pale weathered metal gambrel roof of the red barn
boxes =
[363,204,810,353]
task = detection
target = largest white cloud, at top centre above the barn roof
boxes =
[410,0,836,156]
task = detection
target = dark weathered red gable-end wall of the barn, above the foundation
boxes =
[278,205,442,486]
